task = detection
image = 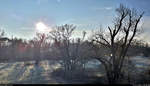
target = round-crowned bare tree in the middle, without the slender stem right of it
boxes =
[50,24,76,70]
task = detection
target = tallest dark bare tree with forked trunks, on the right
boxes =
[92,4,144,83]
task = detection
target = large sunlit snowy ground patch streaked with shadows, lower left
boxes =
[0,61,65,84]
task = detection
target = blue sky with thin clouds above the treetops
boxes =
[0,0,150,41]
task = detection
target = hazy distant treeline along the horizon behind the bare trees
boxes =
[0,28,150,62]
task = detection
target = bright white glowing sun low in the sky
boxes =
[35,22,49,33]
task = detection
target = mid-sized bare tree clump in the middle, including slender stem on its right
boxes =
[50,24,86,77]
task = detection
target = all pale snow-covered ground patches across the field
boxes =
[0,56,150,84]
